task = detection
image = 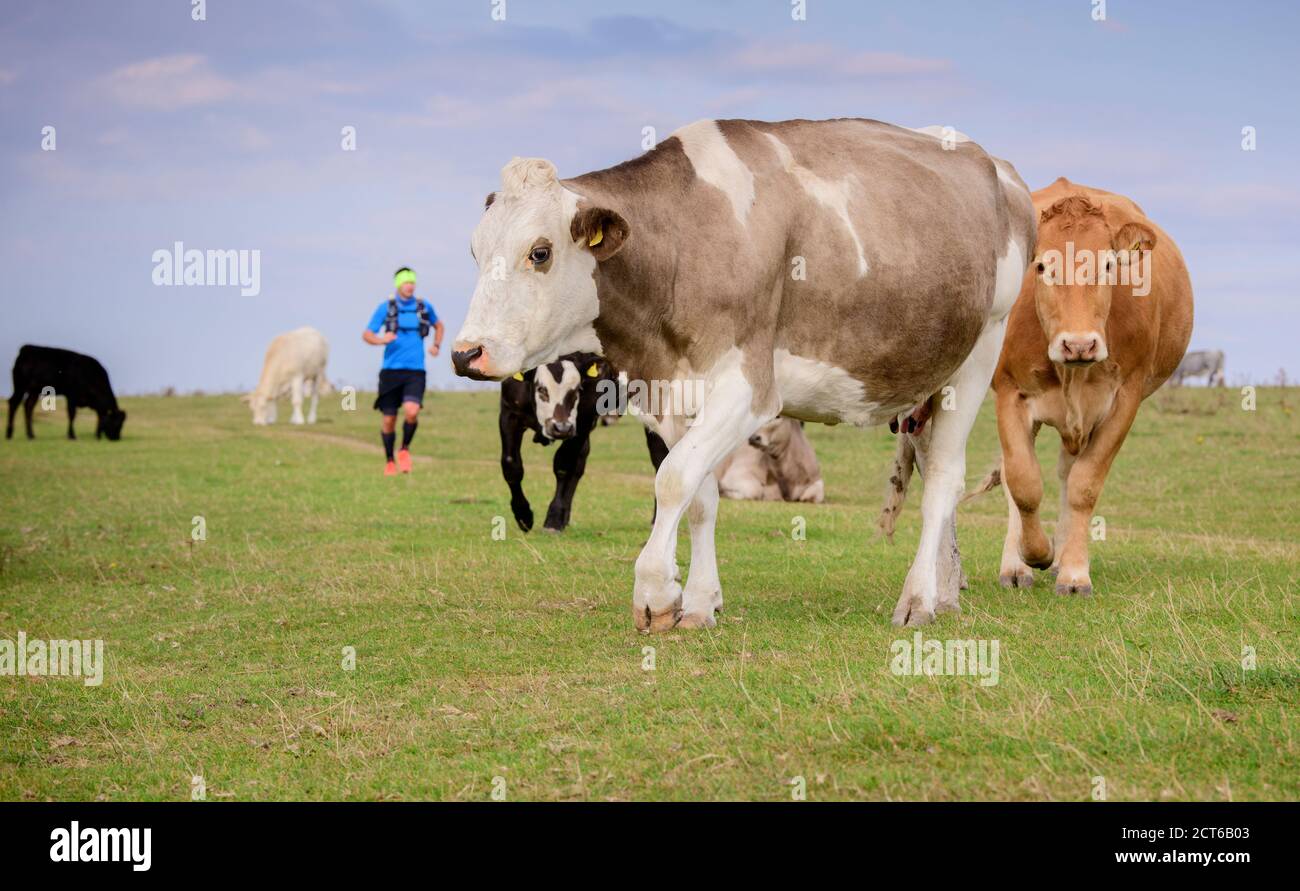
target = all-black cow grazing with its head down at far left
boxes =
[4,343,126,440]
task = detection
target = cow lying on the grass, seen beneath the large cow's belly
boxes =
[714,418,826,503]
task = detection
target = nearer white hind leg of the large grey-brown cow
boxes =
[893,319,1006,626]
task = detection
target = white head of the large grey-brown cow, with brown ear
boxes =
[451,159,627,380]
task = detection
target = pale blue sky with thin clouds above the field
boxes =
[0,0,1300,393]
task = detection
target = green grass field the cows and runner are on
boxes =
[0,388,1300,800]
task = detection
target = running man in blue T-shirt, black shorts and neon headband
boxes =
[361,267,445,476]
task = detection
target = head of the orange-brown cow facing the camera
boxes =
[1032,195,1156,366]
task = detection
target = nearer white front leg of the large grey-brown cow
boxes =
[632,366,779,631]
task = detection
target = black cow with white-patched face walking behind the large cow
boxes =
[501,352,668,532]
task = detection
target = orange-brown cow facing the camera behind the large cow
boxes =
[983,177,1192,594]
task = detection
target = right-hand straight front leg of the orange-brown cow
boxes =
[1056,385,1141,596]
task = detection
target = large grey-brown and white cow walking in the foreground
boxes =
[452,120,1036,631]
